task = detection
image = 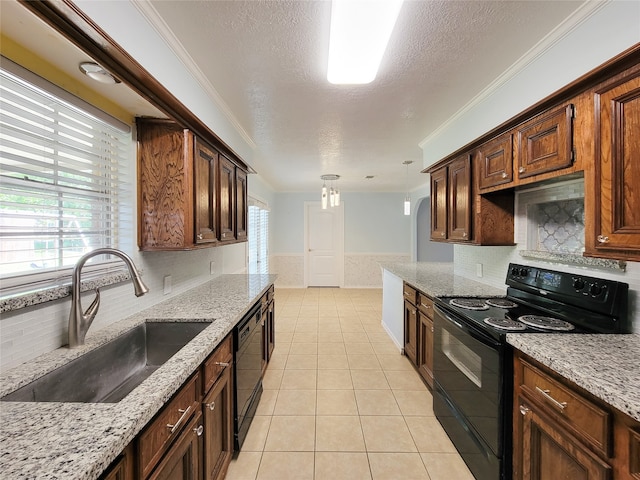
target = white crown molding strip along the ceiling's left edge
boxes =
[131,0,256,149]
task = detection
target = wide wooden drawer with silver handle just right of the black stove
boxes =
[521,362,613,458]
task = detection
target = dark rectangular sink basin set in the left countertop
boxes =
[0,322,211,403]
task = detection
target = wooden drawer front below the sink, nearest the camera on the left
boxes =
[138,373,200,478]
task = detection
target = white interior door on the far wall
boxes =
[305,202,344,287]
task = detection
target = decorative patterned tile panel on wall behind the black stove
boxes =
[527,198,584,253]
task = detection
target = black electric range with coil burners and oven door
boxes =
[433,264,630,480]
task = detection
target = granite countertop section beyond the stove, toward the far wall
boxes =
[380,262,506,297]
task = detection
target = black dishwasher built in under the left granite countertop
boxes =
[233,302,262,453]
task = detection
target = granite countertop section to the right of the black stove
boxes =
[507,333,640,422]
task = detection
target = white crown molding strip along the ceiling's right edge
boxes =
[418,0,612,148]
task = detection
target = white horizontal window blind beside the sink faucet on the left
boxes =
[0,59,133,288]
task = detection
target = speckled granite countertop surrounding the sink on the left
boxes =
[0,275,276,480]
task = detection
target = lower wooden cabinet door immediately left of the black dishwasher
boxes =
[202,368,233,480]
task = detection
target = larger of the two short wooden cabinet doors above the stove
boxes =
[517,105,573,178]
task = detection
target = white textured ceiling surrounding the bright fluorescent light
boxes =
[146,0,582,191]
